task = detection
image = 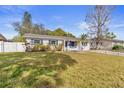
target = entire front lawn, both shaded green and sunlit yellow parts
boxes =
[0,52,124,87]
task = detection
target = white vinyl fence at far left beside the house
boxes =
[0,41,25,52]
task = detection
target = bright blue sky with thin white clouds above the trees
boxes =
[0,5,124,40]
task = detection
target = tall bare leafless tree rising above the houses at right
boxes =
[86,5,114,49]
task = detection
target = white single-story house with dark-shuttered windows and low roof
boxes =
[24,33,90,51]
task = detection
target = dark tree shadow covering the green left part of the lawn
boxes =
[0,52,77,88]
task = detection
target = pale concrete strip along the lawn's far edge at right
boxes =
[90,50,124,56]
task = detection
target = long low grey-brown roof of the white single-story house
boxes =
[24,33,78,41]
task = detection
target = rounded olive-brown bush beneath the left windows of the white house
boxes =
[32,44,50,52]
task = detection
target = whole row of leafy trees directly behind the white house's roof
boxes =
[13,12,75,40]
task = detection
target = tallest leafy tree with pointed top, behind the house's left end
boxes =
[13,12,47,36]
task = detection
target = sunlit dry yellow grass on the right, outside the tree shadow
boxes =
[61,53,124,88]
